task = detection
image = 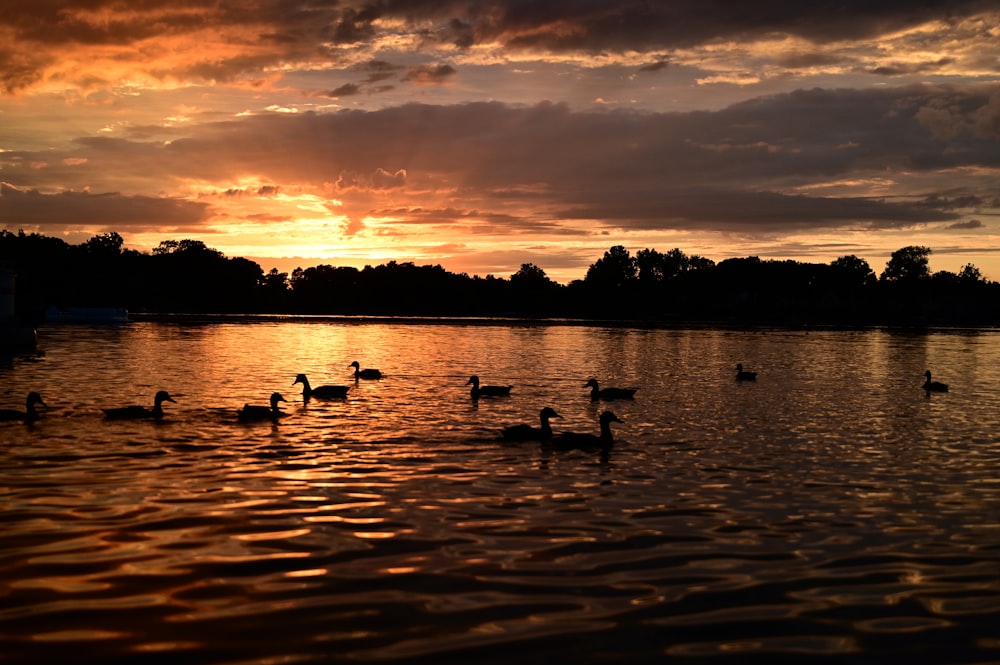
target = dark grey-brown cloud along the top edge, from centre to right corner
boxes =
[408,0,995,51]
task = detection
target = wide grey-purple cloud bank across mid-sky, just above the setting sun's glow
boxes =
[5,81,1000,232]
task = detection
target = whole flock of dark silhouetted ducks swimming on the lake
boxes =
[0,361,948,450]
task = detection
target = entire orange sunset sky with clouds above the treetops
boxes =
[0,0,1000,282]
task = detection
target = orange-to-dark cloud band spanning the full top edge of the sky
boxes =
[0,0,997,91]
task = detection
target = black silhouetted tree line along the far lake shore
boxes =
[0,230,1000,325]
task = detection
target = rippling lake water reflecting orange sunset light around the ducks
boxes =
[0,318,1000,664]
